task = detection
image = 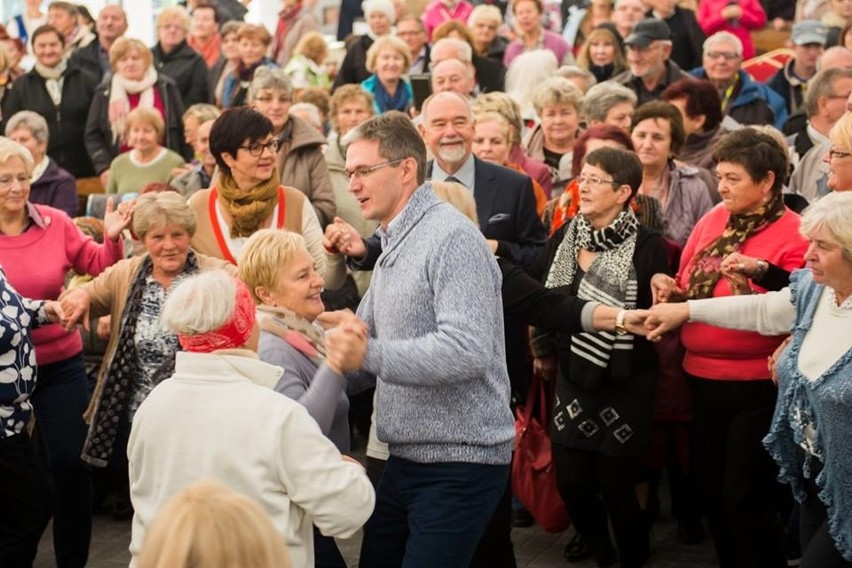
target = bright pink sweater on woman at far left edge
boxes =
[0,204,124,365]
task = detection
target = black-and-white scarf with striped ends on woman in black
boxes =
[545,208,639,387]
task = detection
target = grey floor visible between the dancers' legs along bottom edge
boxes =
[35,504,716,568]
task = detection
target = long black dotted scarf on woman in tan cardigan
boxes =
[82,251,198,467]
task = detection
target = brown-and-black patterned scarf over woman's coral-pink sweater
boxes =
[686,193,786,300]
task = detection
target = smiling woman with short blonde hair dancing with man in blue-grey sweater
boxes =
[239,229,373,568]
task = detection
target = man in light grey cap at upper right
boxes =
[766,20,828,114]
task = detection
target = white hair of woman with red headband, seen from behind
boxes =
[160,270,237,335]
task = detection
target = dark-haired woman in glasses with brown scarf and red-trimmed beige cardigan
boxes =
[189,107,346,290]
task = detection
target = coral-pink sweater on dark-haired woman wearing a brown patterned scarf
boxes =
[676,203,808,381]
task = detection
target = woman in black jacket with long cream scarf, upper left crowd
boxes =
[85,37,192,187]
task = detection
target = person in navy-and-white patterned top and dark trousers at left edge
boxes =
[0,268,61,566]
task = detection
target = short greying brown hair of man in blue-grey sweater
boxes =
[342,110,430,185]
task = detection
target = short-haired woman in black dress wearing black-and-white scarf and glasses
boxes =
[533,148,668,566]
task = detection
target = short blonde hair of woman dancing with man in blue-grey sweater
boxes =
[237,229,308,304]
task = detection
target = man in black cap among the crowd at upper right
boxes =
[613,18,687,105]
